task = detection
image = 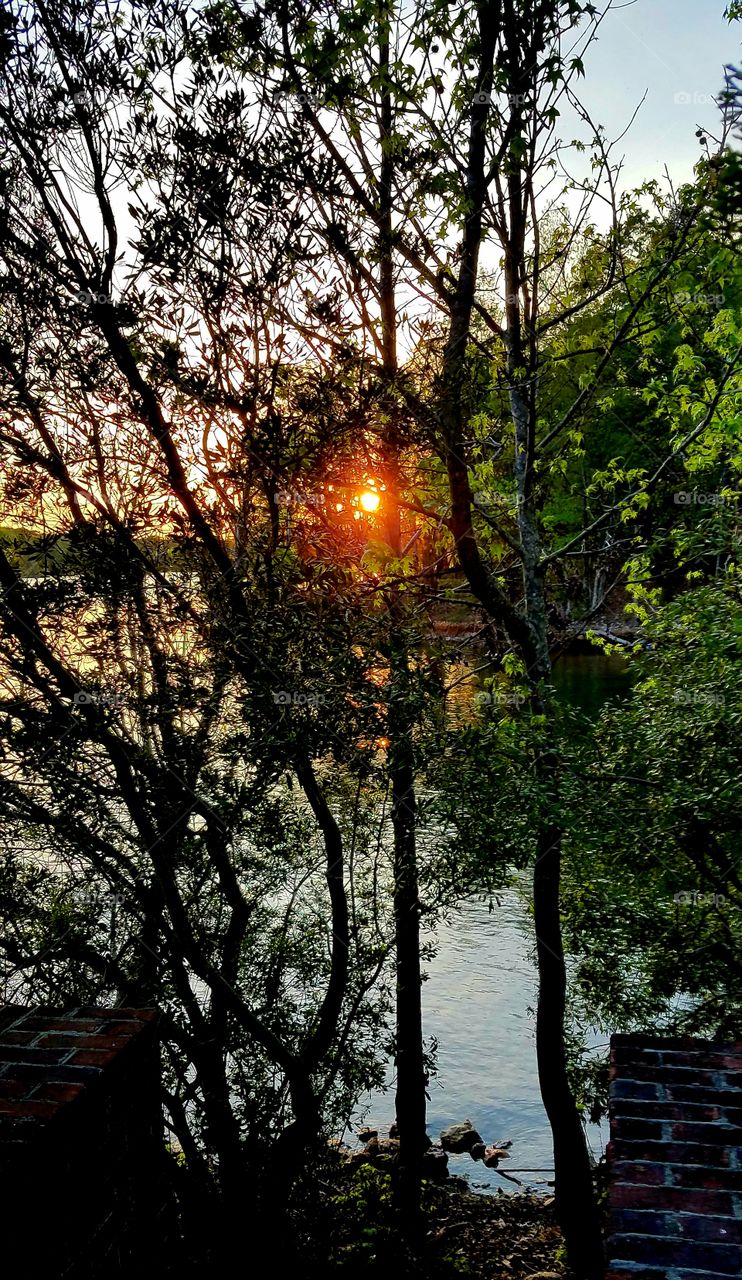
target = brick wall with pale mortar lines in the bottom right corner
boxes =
[606,1036,742,1280]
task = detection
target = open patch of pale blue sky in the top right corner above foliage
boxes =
[580,0,742,188]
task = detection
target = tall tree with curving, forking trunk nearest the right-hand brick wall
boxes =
[240,0,738,1275]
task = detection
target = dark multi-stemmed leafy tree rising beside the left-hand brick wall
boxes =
[0,0,427,1254]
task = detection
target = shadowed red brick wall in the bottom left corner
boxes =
[0,1007,174,1280]
